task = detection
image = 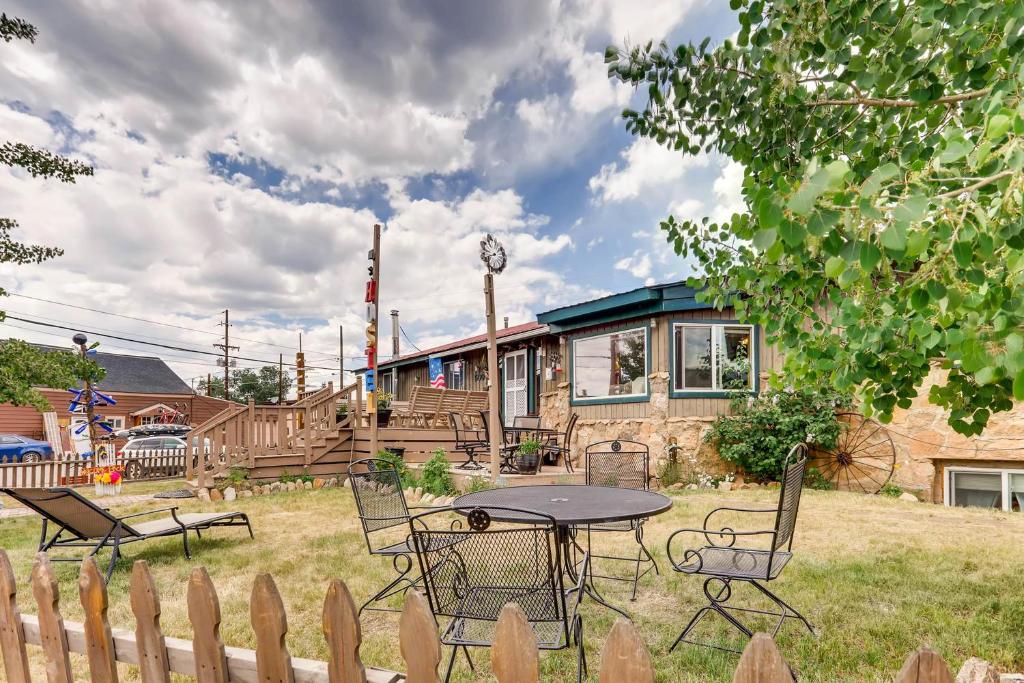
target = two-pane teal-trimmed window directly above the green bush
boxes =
[672,323,755,392]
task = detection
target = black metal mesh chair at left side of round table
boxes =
[348,458,432,614]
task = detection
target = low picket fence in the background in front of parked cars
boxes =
[0,449,185,487]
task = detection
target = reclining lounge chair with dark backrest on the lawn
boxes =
[0,488,255,581]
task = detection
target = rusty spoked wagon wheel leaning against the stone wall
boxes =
[811,413,896,494]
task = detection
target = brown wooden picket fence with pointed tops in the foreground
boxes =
[0,550,953,683]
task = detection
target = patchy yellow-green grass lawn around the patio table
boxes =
[0,485,1024,681]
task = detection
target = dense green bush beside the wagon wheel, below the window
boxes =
[705,389,851,481]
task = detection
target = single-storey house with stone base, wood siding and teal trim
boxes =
[380,283,1024,510]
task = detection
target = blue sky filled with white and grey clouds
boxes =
[0,0,741,383]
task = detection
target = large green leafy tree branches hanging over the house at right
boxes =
[606,0,1024,434]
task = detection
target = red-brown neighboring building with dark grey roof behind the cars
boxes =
[0,345,231,453]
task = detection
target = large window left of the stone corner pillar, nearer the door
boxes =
[572,328,648,400]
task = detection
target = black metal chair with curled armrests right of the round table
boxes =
[666,443,816,652]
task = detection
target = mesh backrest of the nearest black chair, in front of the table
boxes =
[410,506,568,628]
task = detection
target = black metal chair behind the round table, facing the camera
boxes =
[585,439,660,600]
